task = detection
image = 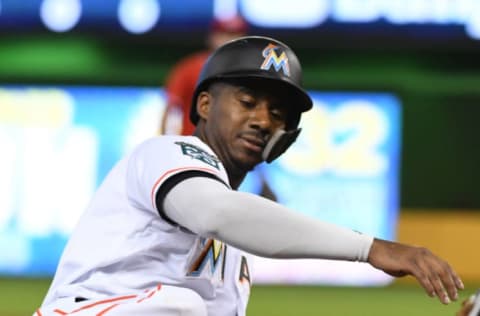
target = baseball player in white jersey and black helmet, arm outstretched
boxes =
[34,36,463,316]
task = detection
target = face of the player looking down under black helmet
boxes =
[201,83,289,171]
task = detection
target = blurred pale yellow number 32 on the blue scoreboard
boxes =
[280,100,391,177]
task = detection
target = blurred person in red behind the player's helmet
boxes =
[160,16,247,135]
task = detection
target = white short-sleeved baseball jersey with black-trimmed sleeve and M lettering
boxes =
[43,136,250,316]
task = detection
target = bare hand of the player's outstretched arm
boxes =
[368,239,464,304]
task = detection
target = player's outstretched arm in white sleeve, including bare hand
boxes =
[163,177,463,304]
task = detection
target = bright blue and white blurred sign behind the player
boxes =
[0,86,401,286]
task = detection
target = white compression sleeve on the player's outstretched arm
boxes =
[163,177,373,261]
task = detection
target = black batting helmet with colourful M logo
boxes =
[190,36,312,128]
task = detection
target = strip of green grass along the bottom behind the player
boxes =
[0,278,479,316]
